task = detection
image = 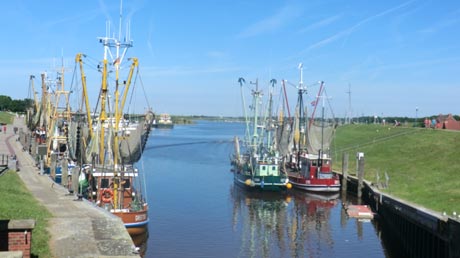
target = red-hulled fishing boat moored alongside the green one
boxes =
[283,65,340,193]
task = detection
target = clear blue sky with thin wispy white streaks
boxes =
[0,0,460,117]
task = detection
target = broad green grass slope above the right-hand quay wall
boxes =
[332,125,460,214]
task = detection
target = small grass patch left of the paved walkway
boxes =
[0,171,51,257]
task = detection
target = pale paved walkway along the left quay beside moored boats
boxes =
[0,118,139,258]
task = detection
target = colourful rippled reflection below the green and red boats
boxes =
[230,186,339,257]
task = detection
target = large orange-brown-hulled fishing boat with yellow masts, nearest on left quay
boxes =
[75,12,154,236]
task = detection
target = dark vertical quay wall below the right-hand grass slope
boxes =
[337,173,460,258]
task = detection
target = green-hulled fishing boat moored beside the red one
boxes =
[231,78,291,191]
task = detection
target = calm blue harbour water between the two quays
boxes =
[139,121,388,257]
